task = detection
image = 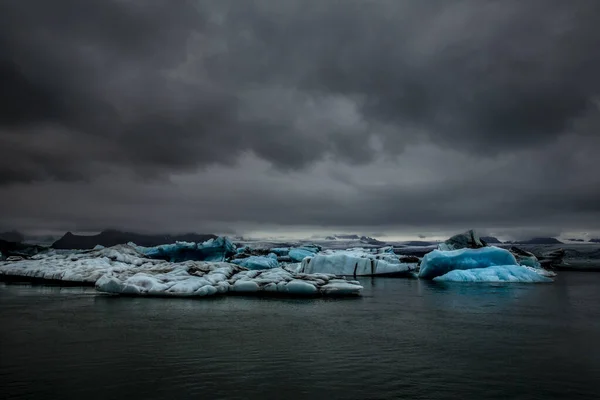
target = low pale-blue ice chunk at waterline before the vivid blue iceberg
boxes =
[433,265,552,283]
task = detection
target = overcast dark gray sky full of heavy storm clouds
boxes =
[0,0,600,236]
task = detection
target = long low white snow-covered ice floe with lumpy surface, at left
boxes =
[0,245,362,297]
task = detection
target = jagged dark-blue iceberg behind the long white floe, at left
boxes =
[130,236,236,262]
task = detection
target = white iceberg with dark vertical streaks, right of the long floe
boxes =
[298,248,417,276]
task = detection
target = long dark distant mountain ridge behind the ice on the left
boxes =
[52,230,217,250]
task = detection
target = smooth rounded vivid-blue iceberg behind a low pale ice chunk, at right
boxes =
[419,246,518,279]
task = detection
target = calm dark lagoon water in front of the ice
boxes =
[0,272,600,399]
